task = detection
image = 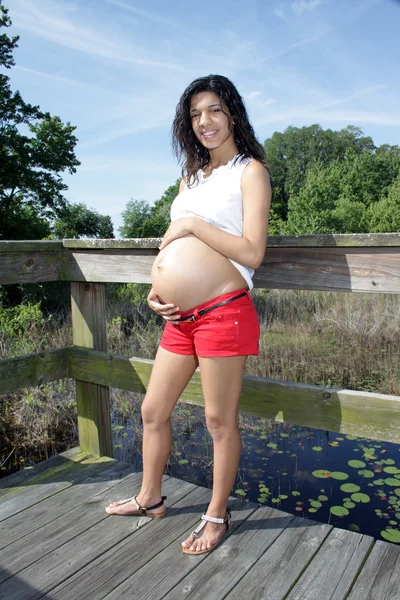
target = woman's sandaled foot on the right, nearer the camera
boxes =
[182,511,232,554]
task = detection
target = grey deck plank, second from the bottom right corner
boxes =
[286,529,374,600]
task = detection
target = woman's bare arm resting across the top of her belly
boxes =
[160,161,271,269]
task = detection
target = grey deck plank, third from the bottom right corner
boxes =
[224,518,332,600]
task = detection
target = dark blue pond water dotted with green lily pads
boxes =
[114,406,400,543]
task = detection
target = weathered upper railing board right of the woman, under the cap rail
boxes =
[254,247,400,293]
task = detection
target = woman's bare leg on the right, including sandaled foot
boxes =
[182,356,247,551]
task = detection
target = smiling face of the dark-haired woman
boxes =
[190,92,234,150]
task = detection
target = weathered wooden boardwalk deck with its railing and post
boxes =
[0,234,400,600]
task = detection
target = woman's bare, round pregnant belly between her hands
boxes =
[151,235,246,311]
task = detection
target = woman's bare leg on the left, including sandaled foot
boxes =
[106,347,198,515]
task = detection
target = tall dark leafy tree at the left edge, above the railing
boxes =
[0,5,80,239]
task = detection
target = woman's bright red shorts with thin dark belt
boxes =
[160,288,260,358]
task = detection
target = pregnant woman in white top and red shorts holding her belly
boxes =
[106,75,271,554]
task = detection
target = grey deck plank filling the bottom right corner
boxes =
[347,541,400,600]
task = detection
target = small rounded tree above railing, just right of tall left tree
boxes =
[53,204,114,239]
